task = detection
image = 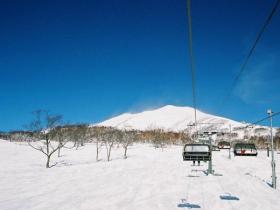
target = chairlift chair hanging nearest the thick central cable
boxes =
[183,144,211,161]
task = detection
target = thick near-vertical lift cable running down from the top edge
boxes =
[187,0,197,130]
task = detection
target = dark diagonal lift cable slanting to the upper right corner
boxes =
[221,0,280,107]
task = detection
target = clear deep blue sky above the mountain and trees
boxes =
[0,0,280,130]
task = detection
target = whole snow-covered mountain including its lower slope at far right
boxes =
[96,105,274,138]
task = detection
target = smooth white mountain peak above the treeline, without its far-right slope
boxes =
[97,105,242,131]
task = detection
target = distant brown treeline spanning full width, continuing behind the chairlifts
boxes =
[0,124,280,149]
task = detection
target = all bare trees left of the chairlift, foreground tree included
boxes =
[0,110,190,168]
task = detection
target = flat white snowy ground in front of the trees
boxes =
[0,140,280,210]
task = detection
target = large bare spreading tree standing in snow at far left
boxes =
[28,110,66,168]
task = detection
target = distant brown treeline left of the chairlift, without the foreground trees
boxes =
[0,124,191,144]
